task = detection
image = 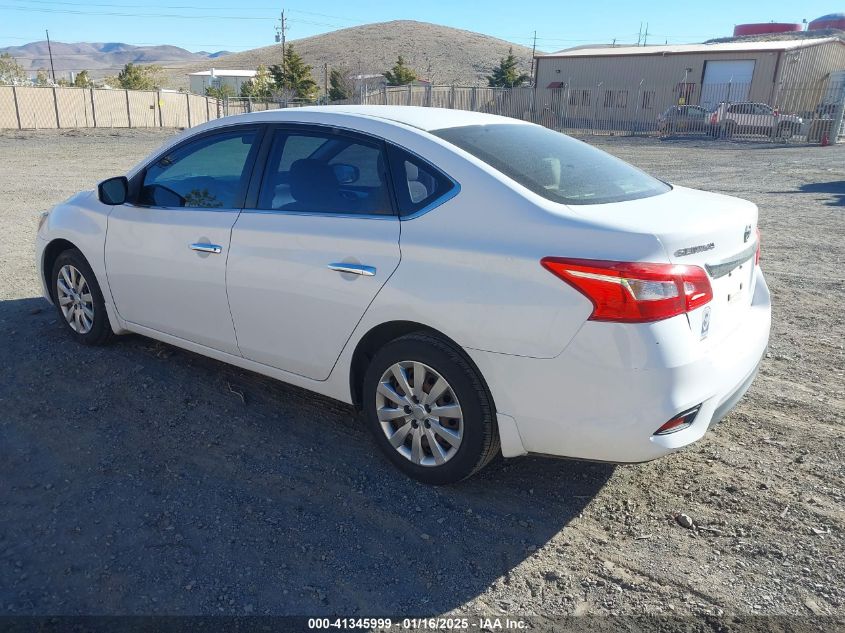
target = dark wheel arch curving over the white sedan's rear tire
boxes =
[349,321,496,413]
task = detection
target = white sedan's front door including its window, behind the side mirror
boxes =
[106,126,262,354]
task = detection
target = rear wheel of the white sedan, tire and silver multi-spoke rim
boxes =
[362,333,499,485]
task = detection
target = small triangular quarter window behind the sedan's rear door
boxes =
[388,145,455,216]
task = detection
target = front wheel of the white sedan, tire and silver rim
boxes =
[51,248,113,345]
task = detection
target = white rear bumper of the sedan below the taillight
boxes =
[468,268,771,462]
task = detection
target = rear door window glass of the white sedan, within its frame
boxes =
[258,130,393,215]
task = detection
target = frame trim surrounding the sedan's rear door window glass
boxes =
[242,121,399,220]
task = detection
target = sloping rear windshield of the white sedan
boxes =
[432,124,671,205]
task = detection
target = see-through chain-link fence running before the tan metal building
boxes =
[362,81,845,143]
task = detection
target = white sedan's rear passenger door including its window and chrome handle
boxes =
[227,125,400,380]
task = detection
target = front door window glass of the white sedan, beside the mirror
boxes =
[137,129,258,209]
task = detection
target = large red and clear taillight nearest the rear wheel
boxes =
[540,257,713,323]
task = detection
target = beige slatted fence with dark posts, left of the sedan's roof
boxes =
[0,86,225,130]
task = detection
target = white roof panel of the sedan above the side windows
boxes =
[211,105,528,131]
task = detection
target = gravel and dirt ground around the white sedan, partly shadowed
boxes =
[0,130,845,622]
